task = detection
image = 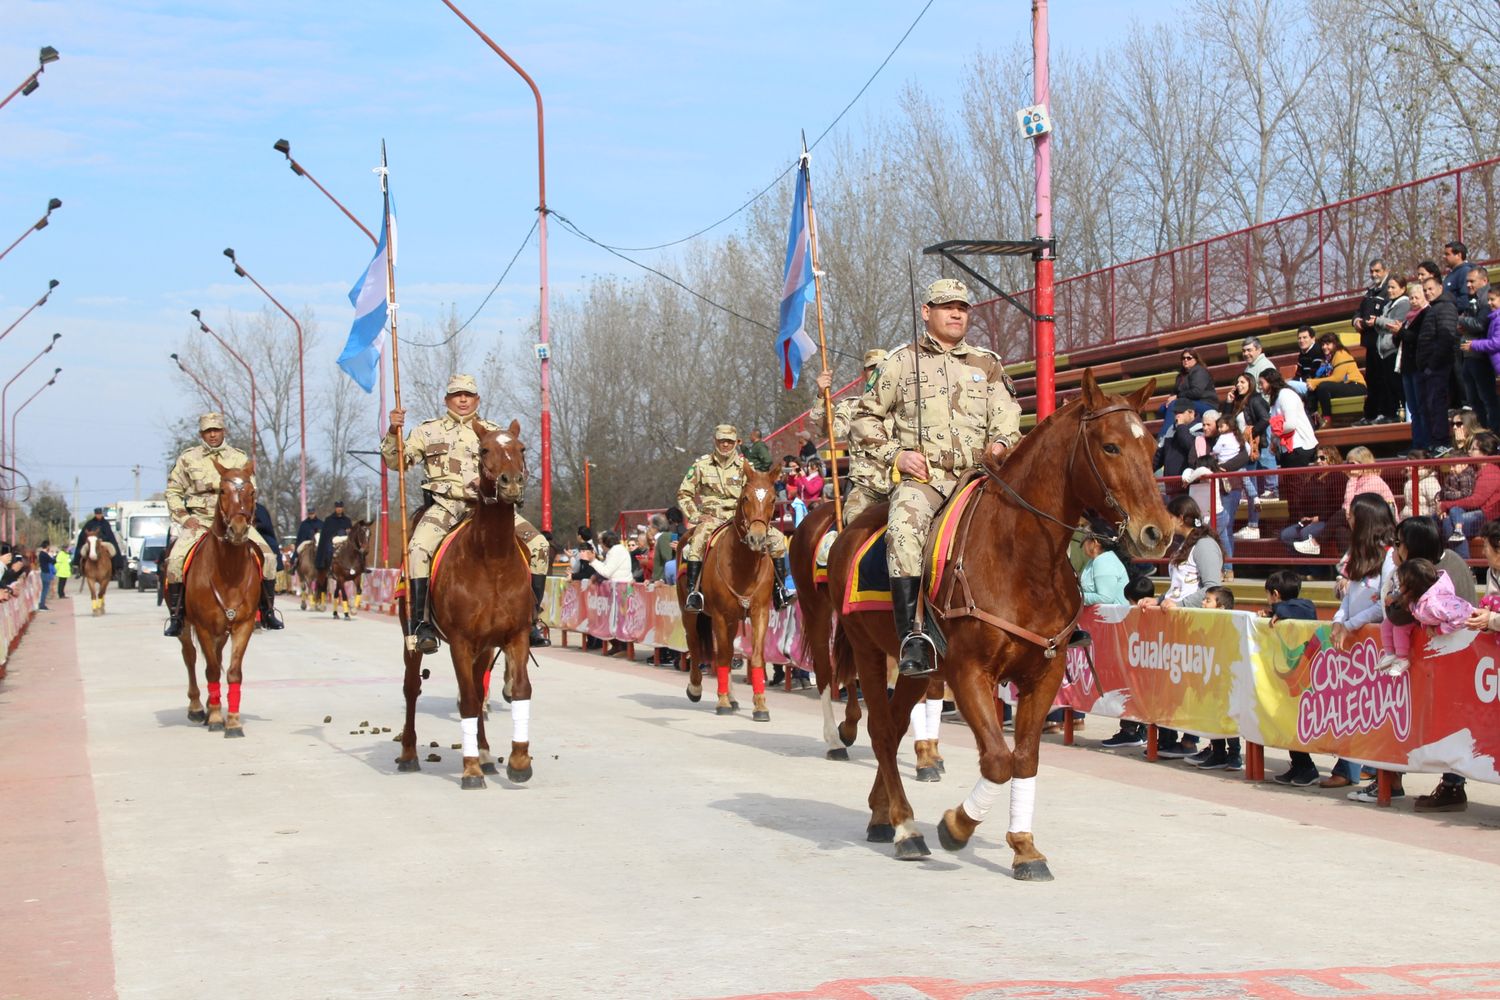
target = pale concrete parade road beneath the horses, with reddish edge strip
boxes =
[0,592,1500,1000]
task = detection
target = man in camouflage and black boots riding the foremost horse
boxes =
[851,277,1022,676]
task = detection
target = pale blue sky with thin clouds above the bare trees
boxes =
[0,0,1128,515]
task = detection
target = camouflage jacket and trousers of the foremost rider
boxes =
[851,333,1022,577]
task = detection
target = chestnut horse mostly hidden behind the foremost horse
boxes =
[786,504,944,781]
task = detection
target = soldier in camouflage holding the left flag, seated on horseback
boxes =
[381,375,551,654]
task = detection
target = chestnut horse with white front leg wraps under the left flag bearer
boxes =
[396,420,534,789]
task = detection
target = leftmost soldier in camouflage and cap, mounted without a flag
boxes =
[162,414,287,637]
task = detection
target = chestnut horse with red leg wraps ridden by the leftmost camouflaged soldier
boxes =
[180,462,261,738]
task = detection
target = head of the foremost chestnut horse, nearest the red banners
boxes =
[1073,369,1172,558]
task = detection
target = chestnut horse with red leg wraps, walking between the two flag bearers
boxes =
[677,462,782,723]
